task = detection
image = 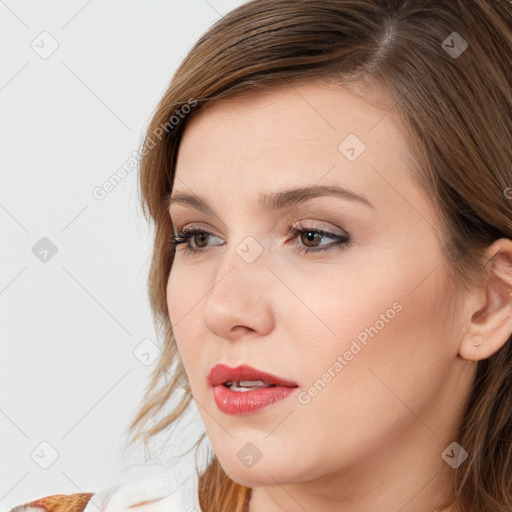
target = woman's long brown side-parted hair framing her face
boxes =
[124,0,512,512]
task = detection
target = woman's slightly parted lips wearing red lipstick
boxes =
[208,364,299,414]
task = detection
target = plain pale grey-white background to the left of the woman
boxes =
[0,0,248,510]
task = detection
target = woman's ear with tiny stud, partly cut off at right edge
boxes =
[459,238,512,361]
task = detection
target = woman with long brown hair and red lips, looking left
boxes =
[10,0,512,512]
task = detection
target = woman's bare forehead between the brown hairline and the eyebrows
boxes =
[175,82,414,214]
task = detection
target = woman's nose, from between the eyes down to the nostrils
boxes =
[203,241,275,340]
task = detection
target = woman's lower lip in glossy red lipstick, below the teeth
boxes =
[213,384,299,414]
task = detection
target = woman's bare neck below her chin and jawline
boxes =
[247,427,456,512]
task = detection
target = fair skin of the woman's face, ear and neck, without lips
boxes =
[167,83,512,512]
